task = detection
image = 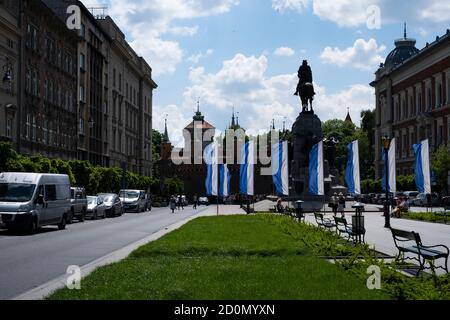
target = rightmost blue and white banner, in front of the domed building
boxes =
[413,139,431,194]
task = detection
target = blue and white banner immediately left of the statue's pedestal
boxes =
[272,141,289,196]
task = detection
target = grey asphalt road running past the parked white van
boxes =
[0,207,204,299]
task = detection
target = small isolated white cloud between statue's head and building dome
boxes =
[320,38,386,71]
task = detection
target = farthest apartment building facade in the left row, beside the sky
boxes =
[99,16,157,175]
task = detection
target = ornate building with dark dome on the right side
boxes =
[371,27,450,178]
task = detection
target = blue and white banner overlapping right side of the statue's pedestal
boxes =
[309,141,325,196]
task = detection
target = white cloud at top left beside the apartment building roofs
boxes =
[89,0,239,76]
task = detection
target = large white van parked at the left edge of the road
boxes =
[0,172,71,234]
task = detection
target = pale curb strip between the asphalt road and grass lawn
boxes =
[11,212,205,300]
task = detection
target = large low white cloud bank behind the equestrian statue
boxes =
[183,54,374,134]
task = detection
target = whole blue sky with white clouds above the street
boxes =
[82,0,450,145]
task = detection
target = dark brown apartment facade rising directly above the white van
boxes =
[17,0,79,160]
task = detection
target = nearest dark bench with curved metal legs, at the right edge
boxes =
[391,229,449,275]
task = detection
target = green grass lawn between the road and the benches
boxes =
[49,215,390,300]
